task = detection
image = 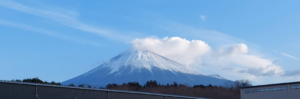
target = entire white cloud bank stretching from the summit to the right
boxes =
[132,37,284,83]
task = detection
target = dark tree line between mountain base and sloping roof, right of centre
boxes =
[106,80,251,99]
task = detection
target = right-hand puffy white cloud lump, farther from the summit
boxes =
[207,44,283,76]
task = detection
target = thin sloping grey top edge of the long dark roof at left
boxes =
[0,80,211,99]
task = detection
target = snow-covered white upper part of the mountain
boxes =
[100,50,200,75]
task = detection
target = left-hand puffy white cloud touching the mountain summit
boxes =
[132,37,210,65]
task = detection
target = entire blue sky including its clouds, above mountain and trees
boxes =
[0,0,300,85]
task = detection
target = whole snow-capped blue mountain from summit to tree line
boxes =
[62,50,228,86]
